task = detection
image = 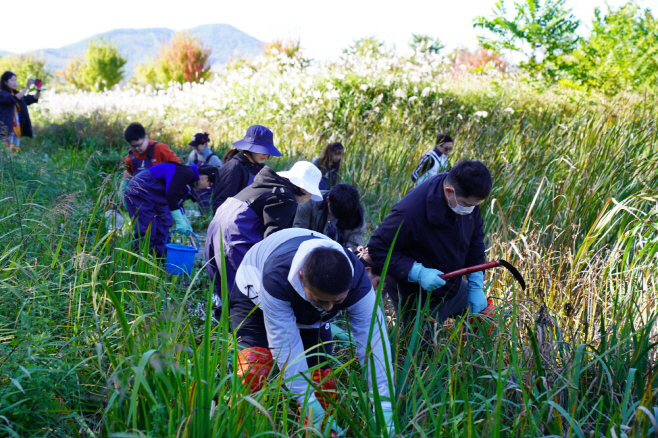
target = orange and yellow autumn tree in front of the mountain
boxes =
[135,32,212,84]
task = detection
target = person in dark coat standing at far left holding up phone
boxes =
[0,71,41,149]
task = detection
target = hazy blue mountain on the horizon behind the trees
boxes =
[0,24,262,76]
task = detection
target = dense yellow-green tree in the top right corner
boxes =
[573,2,658,93]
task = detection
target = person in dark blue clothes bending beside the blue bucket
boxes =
[125,162,216,257]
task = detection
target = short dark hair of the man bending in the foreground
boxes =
[302,247,352,295]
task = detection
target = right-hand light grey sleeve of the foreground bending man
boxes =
[347,288,394,410]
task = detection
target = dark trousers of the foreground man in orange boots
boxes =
[229,286,333,368]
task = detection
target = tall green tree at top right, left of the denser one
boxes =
[473,0,580,76]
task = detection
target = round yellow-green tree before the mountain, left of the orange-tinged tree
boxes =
[59,40,126,93]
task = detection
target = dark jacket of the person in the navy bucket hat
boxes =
[212,154,265,214]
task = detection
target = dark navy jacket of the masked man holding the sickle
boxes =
[368,173,485,298]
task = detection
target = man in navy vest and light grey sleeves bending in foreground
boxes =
[229,228,394,436]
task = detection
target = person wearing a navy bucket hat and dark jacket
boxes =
[212,125,283,213]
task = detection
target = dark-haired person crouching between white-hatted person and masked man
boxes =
[293,184,366,252]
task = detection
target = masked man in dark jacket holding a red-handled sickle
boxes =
[368,161,491,322]
